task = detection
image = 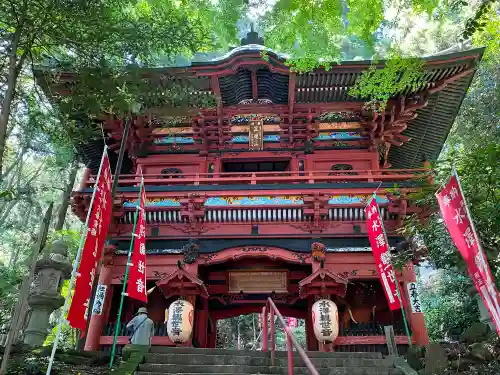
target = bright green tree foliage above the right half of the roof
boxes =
[257,0,487,72]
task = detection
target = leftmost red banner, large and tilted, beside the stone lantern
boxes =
[67,150,112,335]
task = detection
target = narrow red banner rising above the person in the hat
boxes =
[127,184,148,302]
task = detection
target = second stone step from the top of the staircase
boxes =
[145,352,393,368]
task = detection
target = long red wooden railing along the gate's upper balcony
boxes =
[82,168,430,188]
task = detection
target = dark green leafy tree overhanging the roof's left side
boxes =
[0,0,223,179]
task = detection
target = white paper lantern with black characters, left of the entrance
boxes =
[167,299,194,343]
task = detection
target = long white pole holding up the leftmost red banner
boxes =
[45,145,108,375]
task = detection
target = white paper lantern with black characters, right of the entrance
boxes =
[311,299,339,341]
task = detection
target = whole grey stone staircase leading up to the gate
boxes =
[137,346,402,375]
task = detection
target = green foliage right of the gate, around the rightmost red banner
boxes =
[388,4,500,340]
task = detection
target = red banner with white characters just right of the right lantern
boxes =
[365,198,401,310]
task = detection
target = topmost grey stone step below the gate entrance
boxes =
[150,346,382,359]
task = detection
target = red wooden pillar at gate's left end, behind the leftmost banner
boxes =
[84,266,113,351]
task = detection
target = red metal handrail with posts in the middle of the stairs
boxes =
[262,298,319,375]
